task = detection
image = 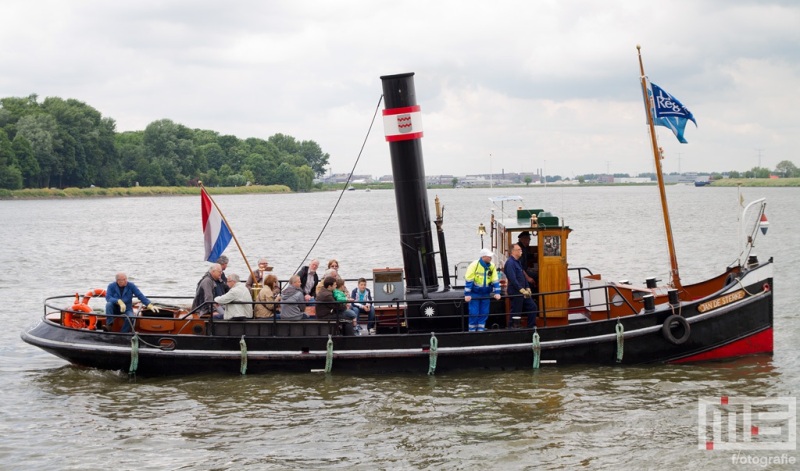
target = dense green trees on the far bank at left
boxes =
[0,95,329,191]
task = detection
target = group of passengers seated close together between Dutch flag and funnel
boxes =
[186,255,375,335]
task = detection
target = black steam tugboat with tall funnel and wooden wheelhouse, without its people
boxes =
[22,67,773,375]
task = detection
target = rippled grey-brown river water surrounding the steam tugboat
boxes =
[0,186,800,470]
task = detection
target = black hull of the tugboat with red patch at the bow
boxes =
[22,269,773,375]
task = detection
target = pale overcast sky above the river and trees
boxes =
[0,0,800,177]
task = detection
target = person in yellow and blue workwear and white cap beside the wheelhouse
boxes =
[464,249,500,332]
